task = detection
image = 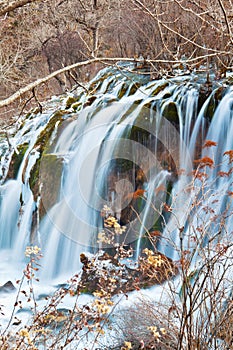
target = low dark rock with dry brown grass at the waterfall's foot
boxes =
[80,252,178,295]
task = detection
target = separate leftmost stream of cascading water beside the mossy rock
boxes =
[0,106,62,278]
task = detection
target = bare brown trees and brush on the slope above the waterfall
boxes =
[0,0,233,125]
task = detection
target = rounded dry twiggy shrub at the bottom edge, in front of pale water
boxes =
[109,297,179,350]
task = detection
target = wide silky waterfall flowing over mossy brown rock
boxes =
[0,68,233,280]
